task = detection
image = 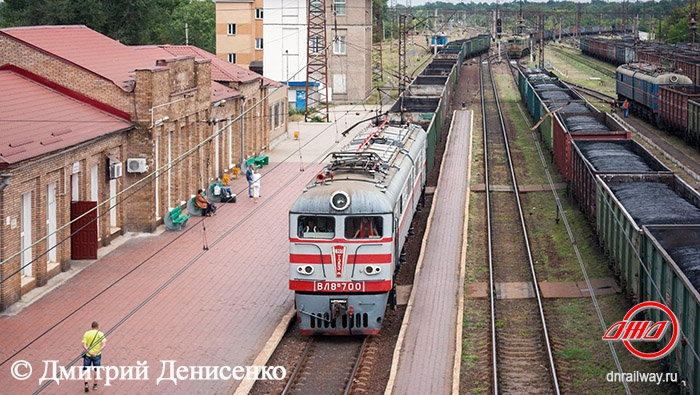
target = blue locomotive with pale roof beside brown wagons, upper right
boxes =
[615,63,693,125]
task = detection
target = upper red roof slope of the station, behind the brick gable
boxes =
[0,25,155,92]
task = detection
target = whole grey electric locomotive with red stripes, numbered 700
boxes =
[289,122,427,335]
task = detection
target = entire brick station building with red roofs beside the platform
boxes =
[0,26,287,311]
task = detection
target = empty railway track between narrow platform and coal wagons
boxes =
[481,53,560,394]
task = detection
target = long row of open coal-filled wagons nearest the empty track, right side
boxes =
[519,69,700,394]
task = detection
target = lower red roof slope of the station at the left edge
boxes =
[0,70,133,166]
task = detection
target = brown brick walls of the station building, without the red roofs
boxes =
[0,28,278,310]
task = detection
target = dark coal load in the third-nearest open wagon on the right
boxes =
[579,142,654,173]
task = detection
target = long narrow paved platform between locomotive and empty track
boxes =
[385,111,473,395]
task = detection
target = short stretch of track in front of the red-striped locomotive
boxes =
[282,336,368,395]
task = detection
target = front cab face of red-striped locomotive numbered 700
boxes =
[289,214,394,335]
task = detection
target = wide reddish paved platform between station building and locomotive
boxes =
[0,106,374,394]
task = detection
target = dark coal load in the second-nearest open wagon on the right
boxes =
[608,182,700,226]
